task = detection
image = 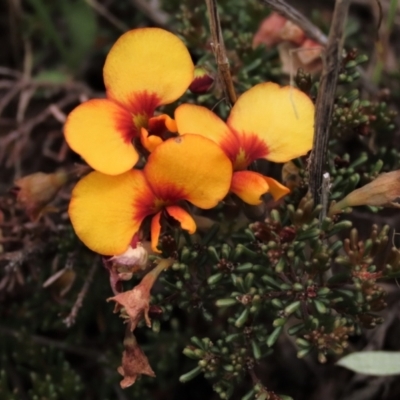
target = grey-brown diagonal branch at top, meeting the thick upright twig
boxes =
[261,0,328,46]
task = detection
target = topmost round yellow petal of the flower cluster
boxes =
[103,28,194,113]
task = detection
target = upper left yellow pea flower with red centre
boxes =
[64,28,194,175]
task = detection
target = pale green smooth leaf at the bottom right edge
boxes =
[336,351,400,376]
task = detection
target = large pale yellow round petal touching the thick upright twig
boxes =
[227,82,314,162]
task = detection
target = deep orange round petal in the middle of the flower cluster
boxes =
[143,134,232,209]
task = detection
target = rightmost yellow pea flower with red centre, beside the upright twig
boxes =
[175,82,314,205]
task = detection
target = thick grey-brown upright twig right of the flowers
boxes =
[309,0,349,205]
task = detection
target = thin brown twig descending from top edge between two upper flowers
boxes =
[206,0,236,106]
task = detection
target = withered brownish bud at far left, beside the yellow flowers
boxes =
[12,170,69,221]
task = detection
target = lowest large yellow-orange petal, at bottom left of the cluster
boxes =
[68,170,154,255]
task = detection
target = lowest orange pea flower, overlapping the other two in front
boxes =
[69,135,232,255]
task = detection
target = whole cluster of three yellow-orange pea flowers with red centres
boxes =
[65,28,314,255]
